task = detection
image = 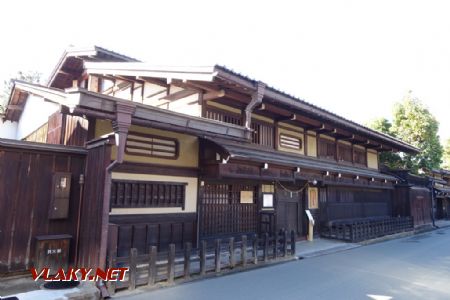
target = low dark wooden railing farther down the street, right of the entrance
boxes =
[321,217,414,242]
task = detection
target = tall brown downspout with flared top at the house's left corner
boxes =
[97,101,136,298]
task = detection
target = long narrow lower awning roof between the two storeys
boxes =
[203,138,398,181]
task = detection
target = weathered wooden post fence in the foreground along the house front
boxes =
[107,230,296,294]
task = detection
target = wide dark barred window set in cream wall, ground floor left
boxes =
[111,180,187,209]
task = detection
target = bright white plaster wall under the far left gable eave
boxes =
[16,95,59,140]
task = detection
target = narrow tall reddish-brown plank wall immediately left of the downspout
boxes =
[77,144,111,268]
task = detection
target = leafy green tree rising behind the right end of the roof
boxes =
[391,92,443,173]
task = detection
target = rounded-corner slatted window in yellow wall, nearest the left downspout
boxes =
[125,132,179,159]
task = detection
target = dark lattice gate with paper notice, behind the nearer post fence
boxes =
[199,184,258,238]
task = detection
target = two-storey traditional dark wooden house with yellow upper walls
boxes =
[0,47,418,274]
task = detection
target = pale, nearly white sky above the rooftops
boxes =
[0,0,450,139]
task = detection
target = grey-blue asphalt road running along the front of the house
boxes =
[117,228,450,300]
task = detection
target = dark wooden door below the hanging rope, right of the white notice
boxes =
[276,187,306,236]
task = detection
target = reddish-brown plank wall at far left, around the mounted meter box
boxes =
[0,147,85,273]
